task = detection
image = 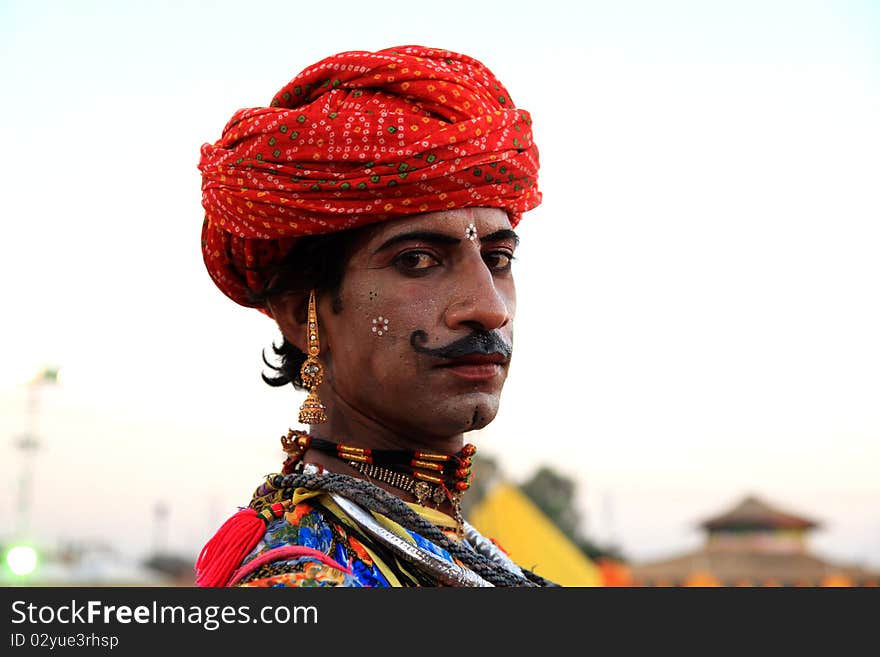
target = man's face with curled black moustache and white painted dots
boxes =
[319,208,517,440]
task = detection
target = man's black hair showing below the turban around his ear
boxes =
[254,226,372,390]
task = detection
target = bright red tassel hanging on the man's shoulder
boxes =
[196,508,274,586]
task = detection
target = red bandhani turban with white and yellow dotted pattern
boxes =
[199,46,541,307]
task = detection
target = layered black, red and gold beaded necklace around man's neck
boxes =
[281,430,477,533]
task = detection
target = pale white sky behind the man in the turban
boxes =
[0,0,880,567]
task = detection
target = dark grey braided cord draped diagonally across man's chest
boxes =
[271,472,556,586]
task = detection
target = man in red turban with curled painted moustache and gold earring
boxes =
[196,46,550,586]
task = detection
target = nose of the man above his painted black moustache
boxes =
[445,260,514,331]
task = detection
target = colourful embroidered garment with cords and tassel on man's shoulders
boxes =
[196,466,532,587]
